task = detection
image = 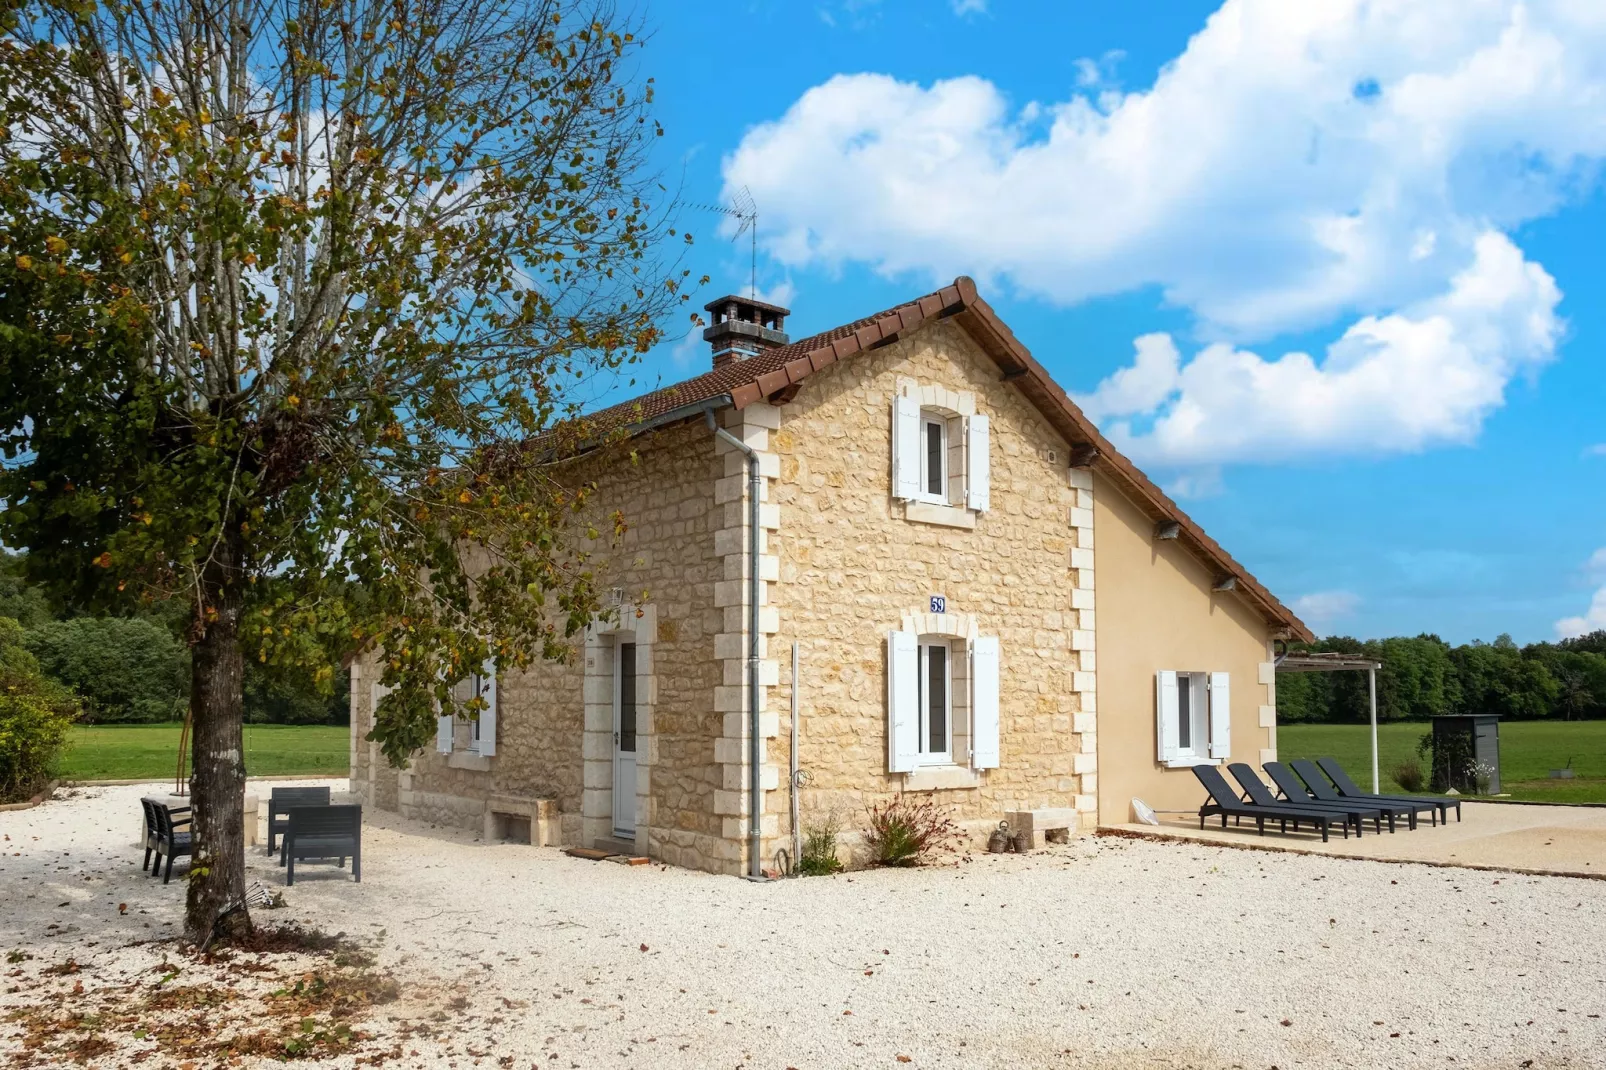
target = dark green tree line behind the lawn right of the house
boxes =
[1277,631,1606,725]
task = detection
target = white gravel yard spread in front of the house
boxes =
[0,787,1606,1070]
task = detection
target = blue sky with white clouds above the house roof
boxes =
[616,0,1606,641]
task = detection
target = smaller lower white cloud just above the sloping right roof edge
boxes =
[1079,231,1561,466]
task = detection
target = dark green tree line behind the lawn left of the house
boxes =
[0,551,350,725]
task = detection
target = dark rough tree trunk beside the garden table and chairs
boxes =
[185,538,251,945]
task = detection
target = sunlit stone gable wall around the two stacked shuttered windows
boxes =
[764,314,1097,855]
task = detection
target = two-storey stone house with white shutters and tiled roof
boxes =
[352,278,1310,874]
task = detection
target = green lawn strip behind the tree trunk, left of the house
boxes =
[61,725,352,781]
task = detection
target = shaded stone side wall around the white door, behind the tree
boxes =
[352,423,726,868]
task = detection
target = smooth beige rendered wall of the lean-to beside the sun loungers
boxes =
[1094,477,1277,824]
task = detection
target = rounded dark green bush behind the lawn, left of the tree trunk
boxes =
[26,617,190,725]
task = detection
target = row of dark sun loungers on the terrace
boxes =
[1193,758,1461,840]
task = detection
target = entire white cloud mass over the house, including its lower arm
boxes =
[724,0,1606,464]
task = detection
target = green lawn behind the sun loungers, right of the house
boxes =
[1277,721,1606,803]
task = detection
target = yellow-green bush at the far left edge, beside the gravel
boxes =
[0,617,79,802]
